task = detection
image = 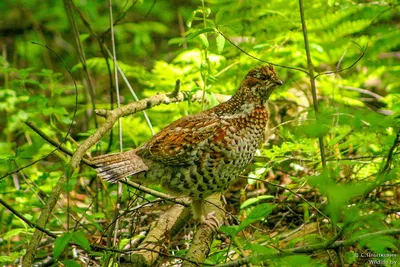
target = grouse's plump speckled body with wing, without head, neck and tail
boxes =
[136,99,268,198]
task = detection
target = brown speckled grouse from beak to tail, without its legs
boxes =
[94,65,282,222]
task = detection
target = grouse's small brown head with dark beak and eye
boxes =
[242,64,283,100]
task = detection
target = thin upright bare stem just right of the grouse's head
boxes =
[299,0,326,168]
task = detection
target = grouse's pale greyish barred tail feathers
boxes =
[93,150,148,182]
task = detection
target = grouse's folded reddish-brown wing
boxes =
[138,113,225,165]
